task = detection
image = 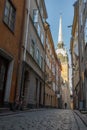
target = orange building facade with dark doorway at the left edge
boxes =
[0,0,25,107]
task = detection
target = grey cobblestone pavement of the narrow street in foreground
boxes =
[0,109,87,130]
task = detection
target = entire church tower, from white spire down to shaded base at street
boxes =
[56,16,70,108]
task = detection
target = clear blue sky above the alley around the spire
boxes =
[45,0,75,53]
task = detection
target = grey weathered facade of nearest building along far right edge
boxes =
[78,0,87,110]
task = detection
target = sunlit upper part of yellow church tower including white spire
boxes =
[56,16,69,82]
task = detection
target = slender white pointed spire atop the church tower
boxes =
[58,16,64,47]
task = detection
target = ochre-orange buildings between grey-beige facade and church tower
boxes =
[45,23,61,108]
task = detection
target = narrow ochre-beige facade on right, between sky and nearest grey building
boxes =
[70,2,80,109]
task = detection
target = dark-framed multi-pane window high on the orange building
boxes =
[4,0,16,31]
